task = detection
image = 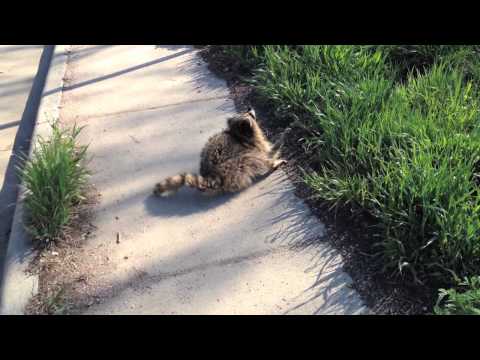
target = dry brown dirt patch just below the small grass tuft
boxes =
[25,187,116,315]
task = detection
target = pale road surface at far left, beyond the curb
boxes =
[0,45,44,282]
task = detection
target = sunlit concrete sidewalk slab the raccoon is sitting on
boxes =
[57,46,367,314]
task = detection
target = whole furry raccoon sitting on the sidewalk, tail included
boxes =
[153,108,286,196]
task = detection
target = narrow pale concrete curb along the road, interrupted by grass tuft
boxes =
[0,45,70,315]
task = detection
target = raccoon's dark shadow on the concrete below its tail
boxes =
[144,187,238,217]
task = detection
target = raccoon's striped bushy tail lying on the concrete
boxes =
[153,173,220,196]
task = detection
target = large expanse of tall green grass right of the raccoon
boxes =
[213,45,480,314]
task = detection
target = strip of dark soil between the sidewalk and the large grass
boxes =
[200,46,436,315]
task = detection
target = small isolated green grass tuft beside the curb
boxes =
[19,123,88,244]
